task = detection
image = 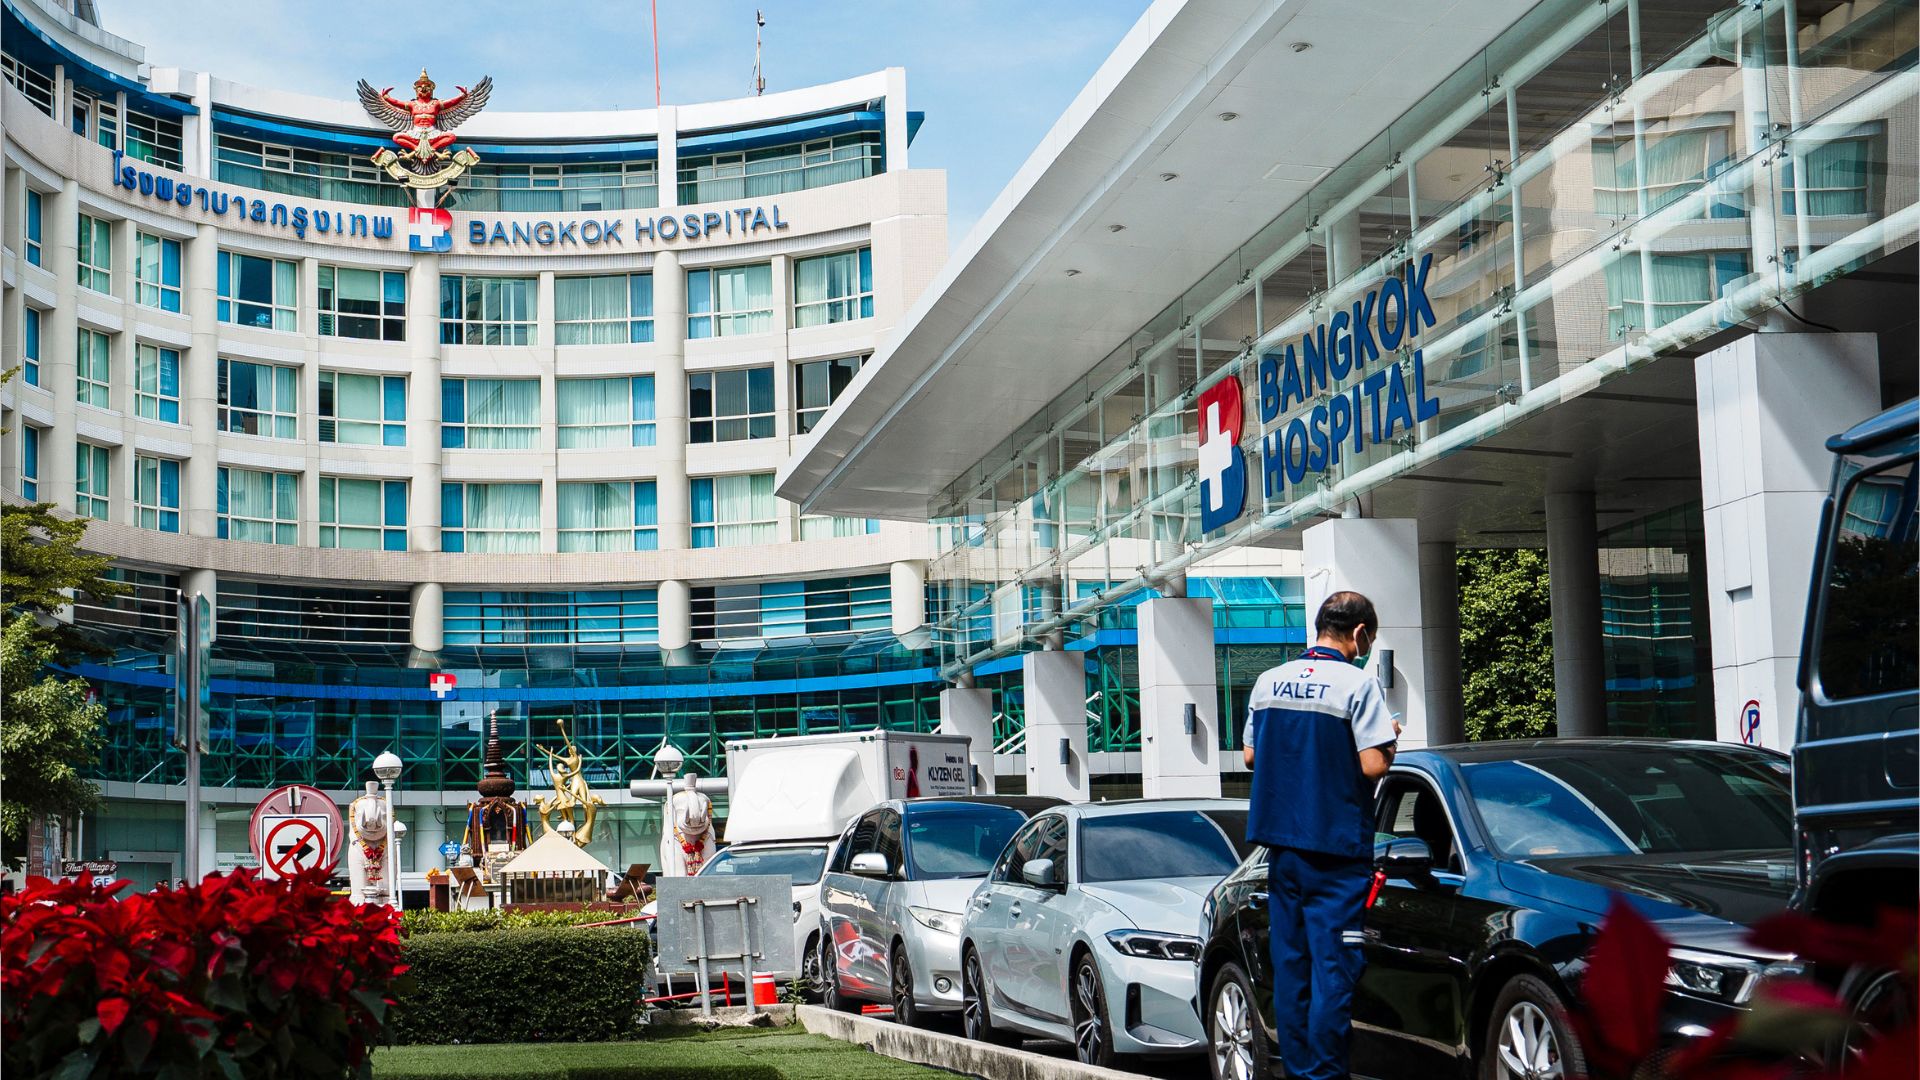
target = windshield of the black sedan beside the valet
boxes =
[1461,746,1793,859]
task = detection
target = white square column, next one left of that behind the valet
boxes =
[1136,596,1219,799]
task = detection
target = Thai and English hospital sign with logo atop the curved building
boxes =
[111,150,789,254]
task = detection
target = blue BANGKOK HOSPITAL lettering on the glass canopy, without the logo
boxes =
[1260,256,1440,500]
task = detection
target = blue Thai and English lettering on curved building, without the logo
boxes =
[113,150,791,248]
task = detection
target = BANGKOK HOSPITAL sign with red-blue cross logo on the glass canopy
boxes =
[1194,256,1440,532]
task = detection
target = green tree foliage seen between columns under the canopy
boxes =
[1457,548,1555,740]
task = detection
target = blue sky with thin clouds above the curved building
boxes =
[100,0,1146,244]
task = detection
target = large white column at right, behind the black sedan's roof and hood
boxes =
[1690,334,1873,749]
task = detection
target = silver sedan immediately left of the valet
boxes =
[960,799,1246,1067]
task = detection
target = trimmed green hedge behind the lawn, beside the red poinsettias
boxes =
[392,926,649,1043]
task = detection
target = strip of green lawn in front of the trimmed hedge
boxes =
[372,1028,952,1080]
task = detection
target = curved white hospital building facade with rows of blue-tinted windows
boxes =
[0,0,947,880]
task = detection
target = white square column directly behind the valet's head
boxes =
[1300,517,1428,748]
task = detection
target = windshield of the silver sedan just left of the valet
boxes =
[1079,811,1246,884]
